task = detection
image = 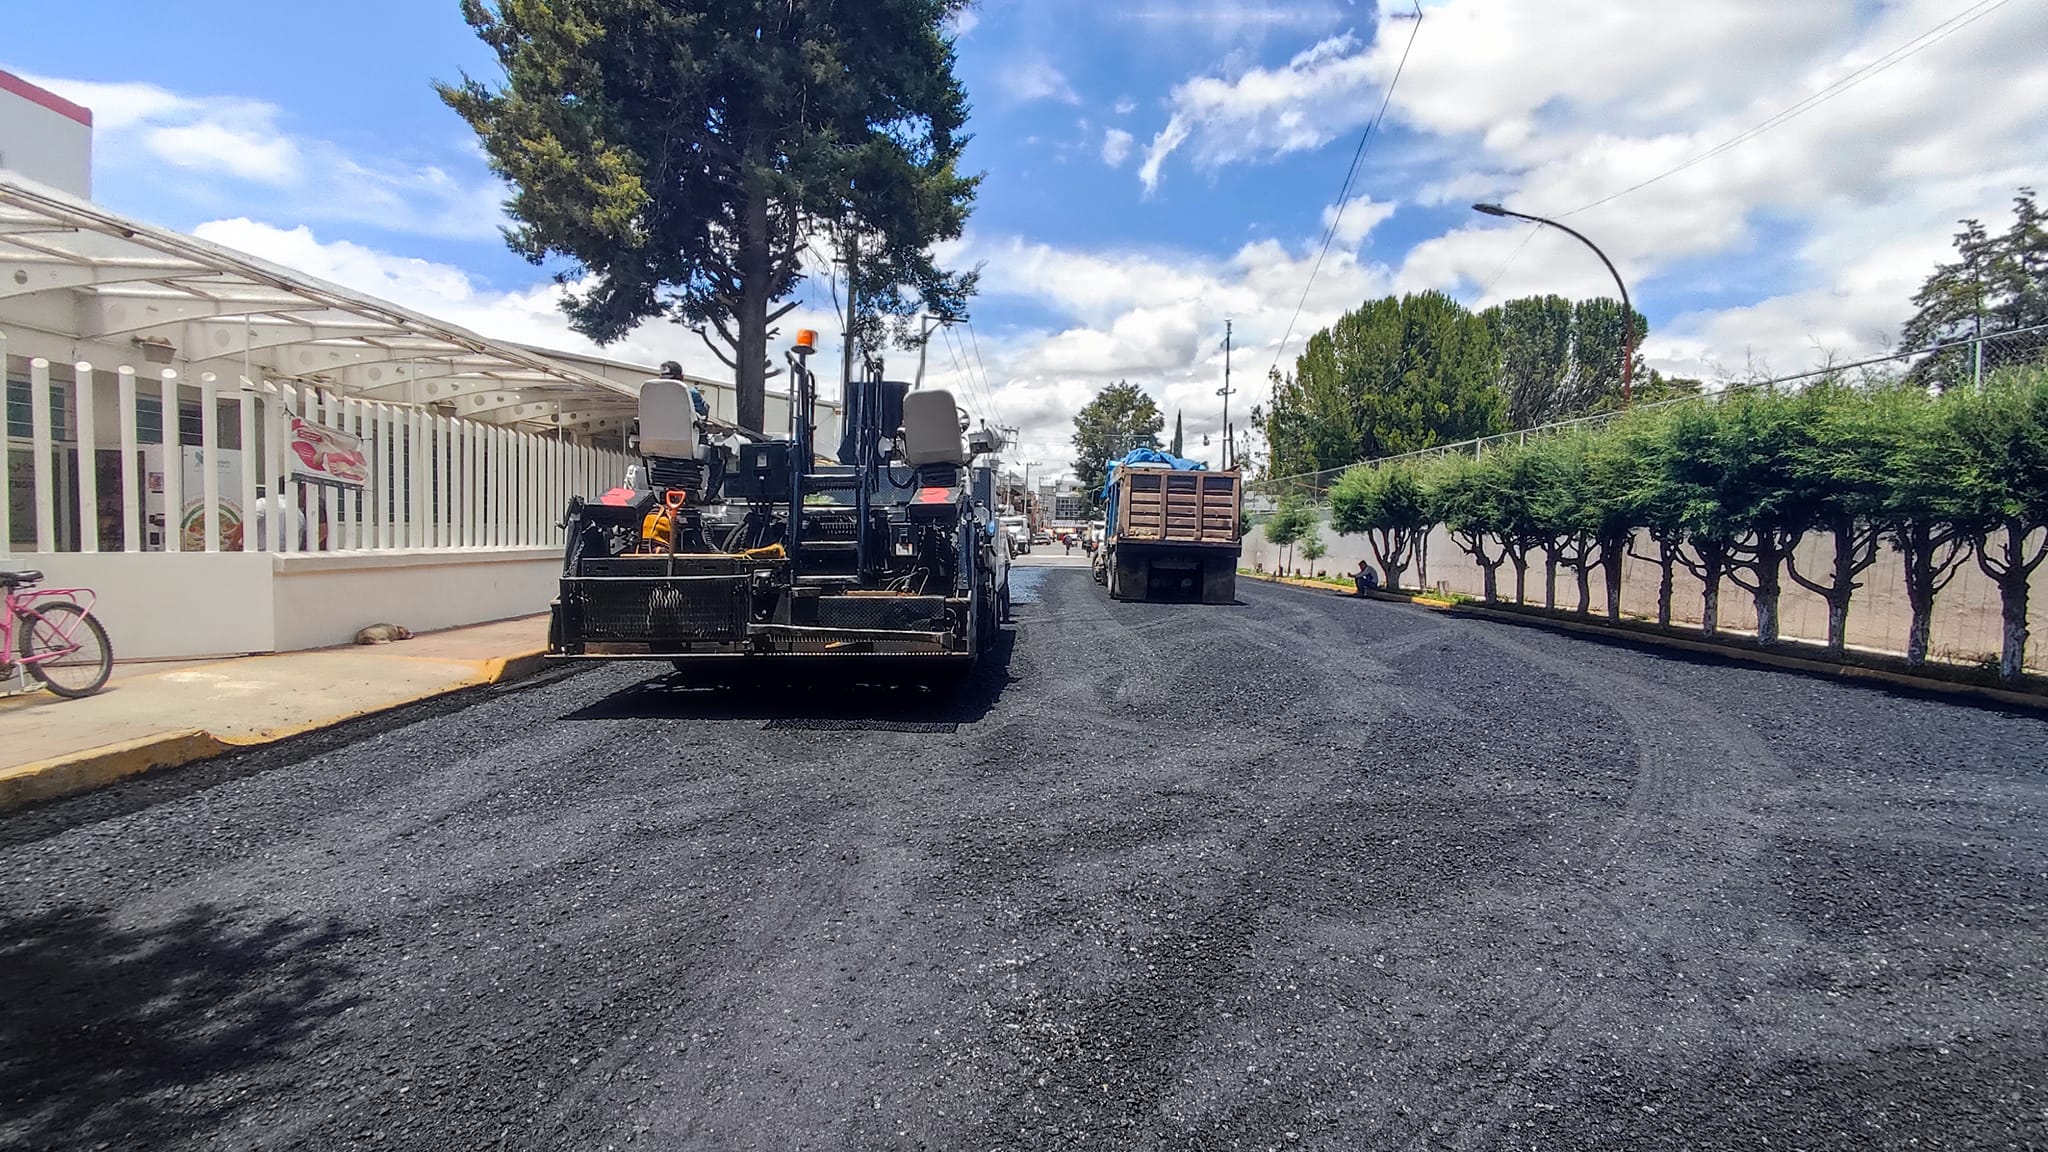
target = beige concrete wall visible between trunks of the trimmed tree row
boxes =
[1243,512,2048,670]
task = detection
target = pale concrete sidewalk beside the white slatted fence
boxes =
[0,615,547,810]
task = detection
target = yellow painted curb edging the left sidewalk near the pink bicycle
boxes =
[0,650,547,812]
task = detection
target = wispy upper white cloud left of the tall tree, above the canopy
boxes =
[31,76,506,240]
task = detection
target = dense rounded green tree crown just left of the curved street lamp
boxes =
[1266,291,1505,476]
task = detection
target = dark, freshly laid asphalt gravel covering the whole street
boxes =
[0,568,2048,1152]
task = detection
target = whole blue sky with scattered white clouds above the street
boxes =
[0,0,2048,475]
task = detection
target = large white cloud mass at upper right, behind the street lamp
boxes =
[1318,0,2048,375]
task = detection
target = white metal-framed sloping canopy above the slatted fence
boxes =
[0,172,637,430]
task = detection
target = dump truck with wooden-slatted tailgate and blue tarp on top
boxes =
[1096,449,1243,605]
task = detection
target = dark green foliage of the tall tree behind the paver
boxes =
[438,0,979,430]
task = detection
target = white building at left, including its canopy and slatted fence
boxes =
[0,74,838,658]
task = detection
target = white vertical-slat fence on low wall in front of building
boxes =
[0,334,629,553]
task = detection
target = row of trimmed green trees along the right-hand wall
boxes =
[1425,367,2048,678]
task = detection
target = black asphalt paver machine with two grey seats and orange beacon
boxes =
[549,332,1008,683]
